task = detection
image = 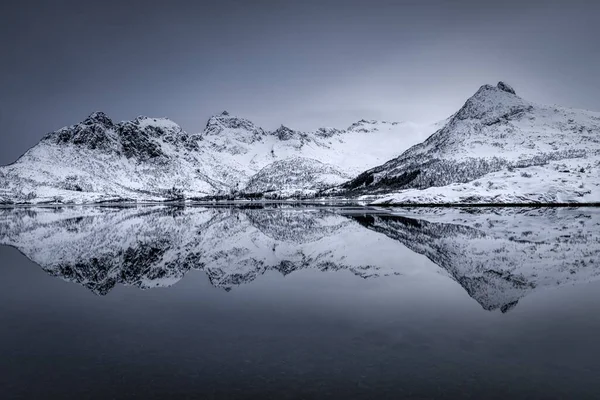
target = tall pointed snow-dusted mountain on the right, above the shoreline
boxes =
[342,82,600,203]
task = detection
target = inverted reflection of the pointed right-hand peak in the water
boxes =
[346,208,600,312]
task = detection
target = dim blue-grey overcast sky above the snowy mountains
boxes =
[0,0,600,164]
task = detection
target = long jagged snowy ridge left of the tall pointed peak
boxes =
[0,112,433,203]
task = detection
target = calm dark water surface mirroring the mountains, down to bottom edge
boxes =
[0,205,600,399]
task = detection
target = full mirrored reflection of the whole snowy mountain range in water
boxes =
[0,206,600,312]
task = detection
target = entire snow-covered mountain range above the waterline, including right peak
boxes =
[0,82,600,204]
